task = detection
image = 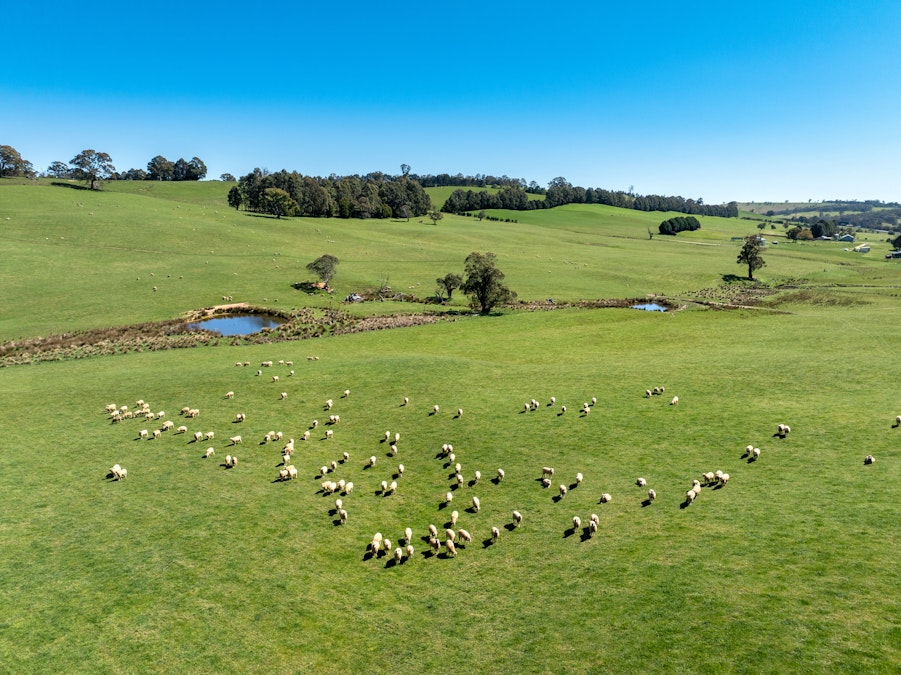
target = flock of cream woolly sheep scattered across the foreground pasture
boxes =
[100,364,901,565]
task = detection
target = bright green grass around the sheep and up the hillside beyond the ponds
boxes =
[0,177,901,673]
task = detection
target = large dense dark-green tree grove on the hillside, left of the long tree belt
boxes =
[229,169,431,218]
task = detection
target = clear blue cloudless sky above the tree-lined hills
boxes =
[0,0,901,203]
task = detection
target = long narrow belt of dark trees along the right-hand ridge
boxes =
[442,178,738,218]
